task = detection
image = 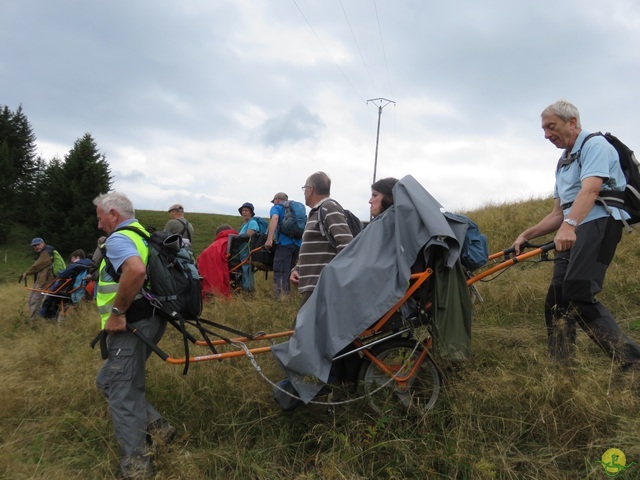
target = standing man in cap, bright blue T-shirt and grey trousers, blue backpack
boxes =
[265,192,302,299]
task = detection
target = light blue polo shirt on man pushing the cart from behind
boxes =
[553,130,629,223]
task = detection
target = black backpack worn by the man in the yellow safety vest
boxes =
[105,225,202,320]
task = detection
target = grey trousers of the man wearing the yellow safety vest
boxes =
[96,316,167,472]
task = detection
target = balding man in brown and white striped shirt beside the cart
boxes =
[289,172,353,306]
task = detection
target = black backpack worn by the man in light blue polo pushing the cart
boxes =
[558,132,640,225]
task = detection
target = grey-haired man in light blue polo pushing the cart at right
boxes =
[513,100,640,372]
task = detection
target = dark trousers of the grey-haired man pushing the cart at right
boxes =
[545,217,640,370]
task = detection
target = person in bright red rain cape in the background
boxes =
[198,225,238,298]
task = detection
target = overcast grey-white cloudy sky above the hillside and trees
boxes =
[0,0,640,219]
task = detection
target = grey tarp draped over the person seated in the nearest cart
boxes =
[271,175,467,403]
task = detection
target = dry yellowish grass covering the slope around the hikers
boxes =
[0,200,640,480]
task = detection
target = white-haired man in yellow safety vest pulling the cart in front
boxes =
[93,192,176,479]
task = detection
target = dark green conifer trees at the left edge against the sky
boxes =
[0,105,113,255]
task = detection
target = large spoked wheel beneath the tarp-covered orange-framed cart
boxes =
[358,339,440,415]
